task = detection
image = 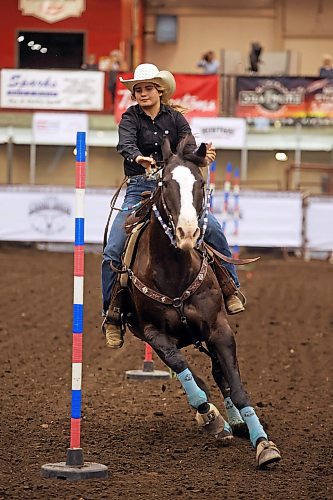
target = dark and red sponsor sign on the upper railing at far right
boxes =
[235,77,333,124]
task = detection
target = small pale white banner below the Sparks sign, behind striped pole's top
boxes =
[32,113,88,146]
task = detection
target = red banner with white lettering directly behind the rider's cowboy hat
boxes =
[114,73,219,123]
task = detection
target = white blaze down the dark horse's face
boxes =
[172,165,198,236]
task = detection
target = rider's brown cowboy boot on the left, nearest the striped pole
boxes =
[102,281,125,349]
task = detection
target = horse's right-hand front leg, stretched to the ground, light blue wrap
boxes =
[207,315,281,467]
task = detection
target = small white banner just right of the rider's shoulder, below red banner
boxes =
[191,118,246,149]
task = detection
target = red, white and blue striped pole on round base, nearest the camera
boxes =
[41,132,108,480]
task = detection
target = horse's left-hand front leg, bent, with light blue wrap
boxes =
[144,325,232,444]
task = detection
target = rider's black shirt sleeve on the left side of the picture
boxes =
[117,110,144,162]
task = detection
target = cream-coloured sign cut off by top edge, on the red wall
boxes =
[19,0,86,24]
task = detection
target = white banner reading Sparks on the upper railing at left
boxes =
[0,69,104,111]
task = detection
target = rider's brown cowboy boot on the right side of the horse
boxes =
[213,258,246,314]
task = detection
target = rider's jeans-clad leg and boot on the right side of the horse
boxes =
[205,212,244,314]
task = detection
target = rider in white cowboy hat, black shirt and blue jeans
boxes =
[102,64,244,348]
